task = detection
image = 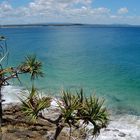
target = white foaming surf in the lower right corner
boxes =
[86,115,140,140]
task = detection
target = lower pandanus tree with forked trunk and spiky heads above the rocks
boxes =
[21,87,109,140]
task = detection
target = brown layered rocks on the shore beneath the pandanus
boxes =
[0,103,85,140]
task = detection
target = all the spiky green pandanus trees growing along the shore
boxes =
[0,36,109,140]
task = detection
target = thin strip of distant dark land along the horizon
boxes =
[0,23,140,28]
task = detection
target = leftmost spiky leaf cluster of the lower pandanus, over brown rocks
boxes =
[20,86,51,122]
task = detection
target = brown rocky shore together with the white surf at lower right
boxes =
[0,103,140,140]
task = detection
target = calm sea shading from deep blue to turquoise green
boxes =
[0,26,140,114]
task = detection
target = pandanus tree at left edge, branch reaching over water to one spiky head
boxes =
[0,36,43,128]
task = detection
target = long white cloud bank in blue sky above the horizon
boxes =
[0,0,140,24]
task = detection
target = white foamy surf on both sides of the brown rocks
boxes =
[3,86,140,140]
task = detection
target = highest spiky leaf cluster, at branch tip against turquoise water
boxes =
[20,55,43,80]
